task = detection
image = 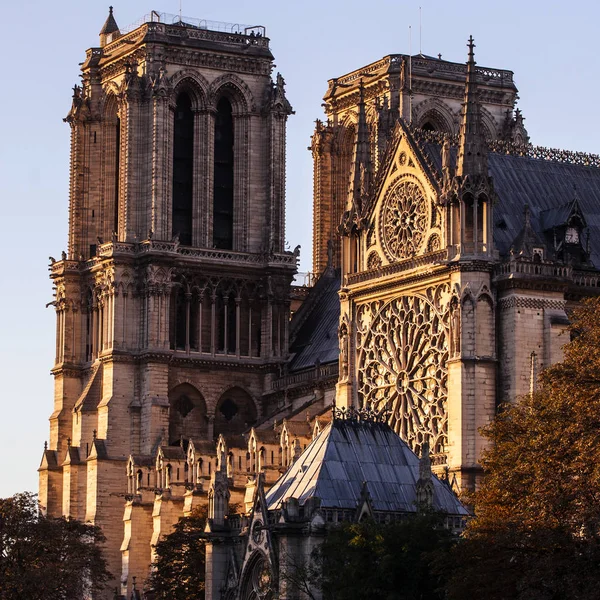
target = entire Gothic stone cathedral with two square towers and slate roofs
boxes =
[39,9,600,600]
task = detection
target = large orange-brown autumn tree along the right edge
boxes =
[445,299,600,600]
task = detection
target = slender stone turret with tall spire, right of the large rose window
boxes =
[440,37,498,488]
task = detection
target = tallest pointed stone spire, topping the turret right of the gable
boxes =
[456,36,488,177]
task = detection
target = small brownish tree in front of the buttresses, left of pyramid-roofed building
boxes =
[148,508,207,600]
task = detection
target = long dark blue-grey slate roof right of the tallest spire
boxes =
[424,143,600,268]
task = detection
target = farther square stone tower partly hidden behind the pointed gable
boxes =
[311,49,528,275]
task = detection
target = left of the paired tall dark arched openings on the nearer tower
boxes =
[173,93,194,246]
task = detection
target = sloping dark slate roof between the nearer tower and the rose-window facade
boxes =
[289,269,340,371]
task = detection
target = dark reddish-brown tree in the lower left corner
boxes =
[0,493,110,600]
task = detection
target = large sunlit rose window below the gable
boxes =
[357,296,448,454]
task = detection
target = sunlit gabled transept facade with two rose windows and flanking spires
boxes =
[336,39,498,487]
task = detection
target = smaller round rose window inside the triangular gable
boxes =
[381,179,428,260]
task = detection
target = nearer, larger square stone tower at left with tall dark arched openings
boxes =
[40,8,296,592]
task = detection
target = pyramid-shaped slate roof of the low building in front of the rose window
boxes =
[266,419,468,515]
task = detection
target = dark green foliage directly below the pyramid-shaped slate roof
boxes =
[319,514,452,600]
